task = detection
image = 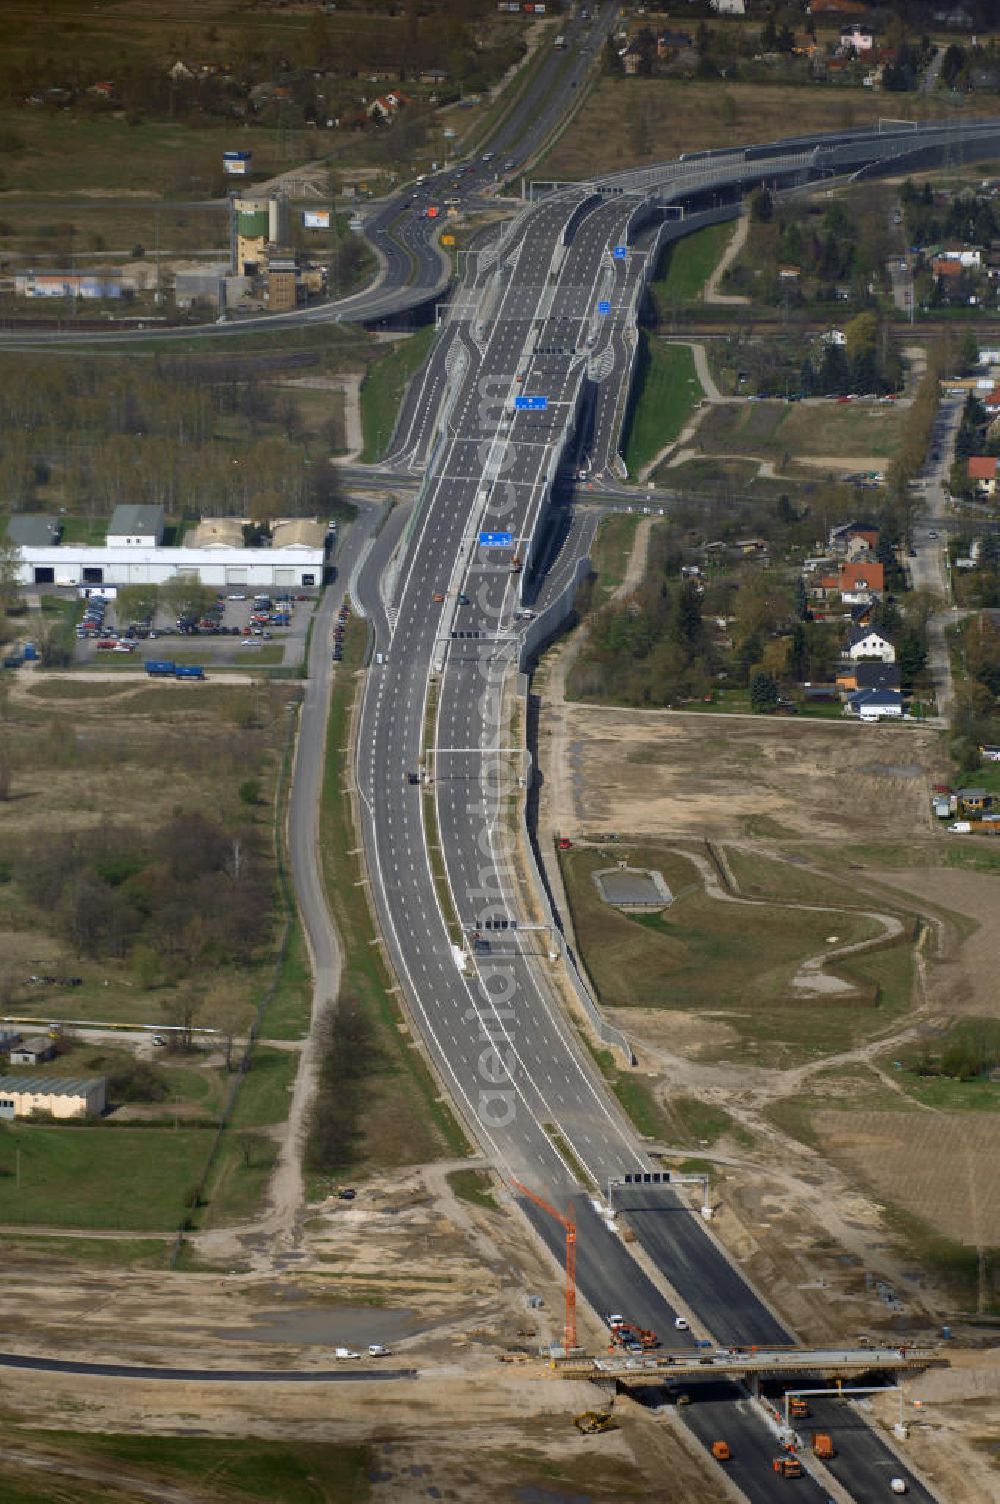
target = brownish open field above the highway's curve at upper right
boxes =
[537,78,955,179]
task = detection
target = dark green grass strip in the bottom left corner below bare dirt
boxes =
[3,1429,370,1504]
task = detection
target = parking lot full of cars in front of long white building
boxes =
[74,588,317,668]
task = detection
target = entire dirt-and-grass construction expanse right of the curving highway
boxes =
[535,658,1000,1504]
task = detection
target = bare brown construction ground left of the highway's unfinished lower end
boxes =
[0,1166,717,1504]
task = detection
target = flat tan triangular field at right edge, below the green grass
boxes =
[814,1113,1000,1247]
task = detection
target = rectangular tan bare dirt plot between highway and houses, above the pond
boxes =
[540,702,944,842]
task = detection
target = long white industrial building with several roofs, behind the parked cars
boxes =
[8,504,328,590]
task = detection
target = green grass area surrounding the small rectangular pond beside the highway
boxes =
[559,845,913,1070]
